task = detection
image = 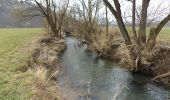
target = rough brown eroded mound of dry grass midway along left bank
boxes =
[30,36,65,75]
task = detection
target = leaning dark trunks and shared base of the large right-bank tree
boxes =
[103,0,170,73]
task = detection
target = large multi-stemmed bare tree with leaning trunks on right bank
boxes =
[103,0,170,71]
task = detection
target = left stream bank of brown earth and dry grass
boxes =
[27,36,66,100]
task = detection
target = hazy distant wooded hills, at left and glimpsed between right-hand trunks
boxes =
[0,0,170,28]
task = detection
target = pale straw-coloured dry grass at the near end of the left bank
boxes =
[32,66,61,100]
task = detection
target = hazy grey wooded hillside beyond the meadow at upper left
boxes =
[0,0,42,28]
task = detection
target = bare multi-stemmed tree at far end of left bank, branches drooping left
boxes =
[16,0,69,37]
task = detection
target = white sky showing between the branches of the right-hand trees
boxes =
[70,0,170,21]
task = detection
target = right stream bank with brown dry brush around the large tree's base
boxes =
[84,36,170,86]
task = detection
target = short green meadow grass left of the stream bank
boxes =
[0,28,42,100]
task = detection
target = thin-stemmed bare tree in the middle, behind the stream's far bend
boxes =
[75,0,100,39]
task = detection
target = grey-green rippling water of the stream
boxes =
[59,37,170,100]
